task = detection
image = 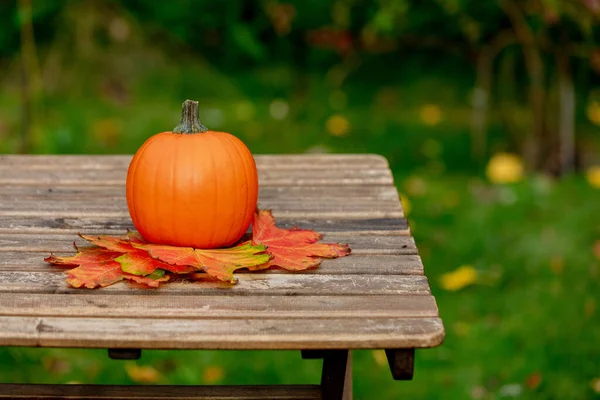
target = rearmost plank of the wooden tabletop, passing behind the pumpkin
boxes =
[0,154,389,170]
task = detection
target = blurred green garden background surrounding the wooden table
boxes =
[0,0,600,400]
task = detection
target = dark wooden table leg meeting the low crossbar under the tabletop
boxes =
[321,350,352,400]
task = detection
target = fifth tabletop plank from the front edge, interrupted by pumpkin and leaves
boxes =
[0,233,417,254]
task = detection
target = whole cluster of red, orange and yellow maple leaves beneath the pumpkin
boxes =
[44,211,350,288]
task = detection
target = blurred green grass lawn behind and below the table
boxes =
[0,55,600,400]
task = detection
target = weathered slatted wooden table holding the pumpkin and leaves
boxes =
[0,155,444,399]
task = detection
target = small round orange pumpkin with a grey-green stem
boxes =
[126,100,258,249]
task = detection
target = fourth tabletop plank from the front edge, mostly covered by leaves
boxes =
[0,251,423,275]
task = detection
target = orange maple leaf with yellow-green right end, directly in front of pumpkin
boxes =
[133,242,271,283]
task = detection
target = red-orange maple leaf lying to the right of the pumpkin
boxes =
[252,210,350,271]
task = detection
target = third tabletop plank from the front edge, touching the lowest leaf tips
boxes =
[0,268,431,297]
